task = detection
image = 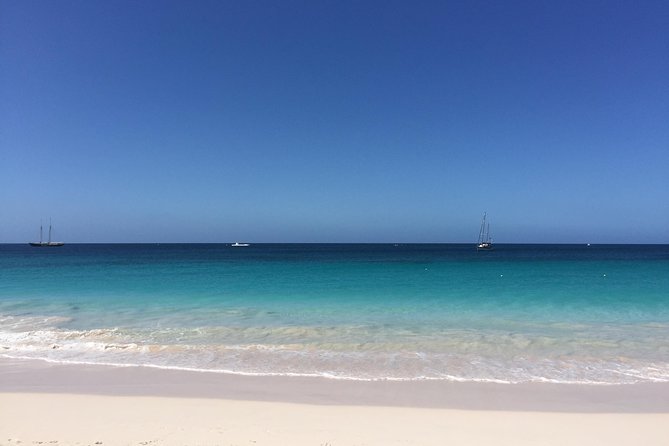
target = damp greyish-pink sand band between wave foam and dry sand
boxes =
[0,358,669,413]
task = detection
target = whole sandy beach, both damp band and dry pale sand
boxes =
[0,359,669,446]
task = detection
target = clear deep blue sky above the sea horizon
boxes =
[0,0,669,243]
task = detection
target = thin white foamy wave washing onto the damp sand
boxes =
[0,343,669,385]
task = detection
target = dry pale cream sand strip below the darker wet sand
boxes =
[5,393,669,446]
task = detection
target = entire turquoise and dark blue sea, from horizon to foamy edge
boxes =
[0,244,669,384]
